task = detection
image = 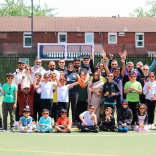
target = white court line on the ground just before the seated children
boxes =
[19,132,156,137]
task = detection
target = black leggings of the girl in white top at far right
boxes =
[146,99,156,124]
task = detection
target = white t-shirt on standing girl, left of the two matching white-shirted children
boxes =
[40,82,53,99]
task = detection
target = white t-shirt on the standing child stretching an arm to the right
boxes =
[57,85,69,102]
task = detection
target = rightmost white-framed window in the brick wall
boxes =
[135,33,144,48]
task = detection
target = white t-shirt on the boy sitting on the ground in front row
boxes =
[82,111,97,126]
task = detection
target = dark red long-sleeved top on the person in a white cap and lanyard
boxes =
[17,84,35,115]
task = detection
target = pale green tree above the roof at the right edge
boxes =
[130,0,156,17]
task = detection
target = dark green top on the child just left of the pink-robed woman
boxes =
[78,82,88,101]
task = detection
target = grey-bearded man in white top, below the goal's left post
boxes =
[31,58,46,81]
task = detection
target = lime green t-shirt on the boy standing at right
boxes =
[124,81,142,102]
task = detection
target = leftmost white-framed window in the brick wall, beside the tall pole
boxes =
[23,32,32,48]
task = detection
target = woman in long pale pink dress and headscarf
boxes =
[88,72,104,121]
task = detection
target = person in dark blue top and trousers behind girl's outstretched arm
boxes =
[65,63,80,127]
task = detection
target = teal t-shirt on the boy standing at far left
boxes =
[2,83,17,103]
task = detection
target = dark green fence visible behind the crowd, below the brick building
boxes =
[0,53,156,84]
